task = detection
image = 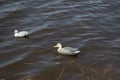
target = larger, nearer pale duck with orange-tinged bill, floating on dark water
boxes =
[54,43,80,55]
